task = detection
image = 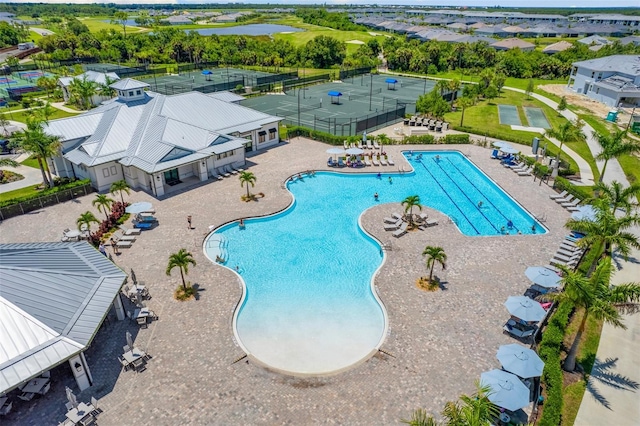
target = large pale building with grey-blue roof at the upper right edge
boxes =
[567,55,640,107]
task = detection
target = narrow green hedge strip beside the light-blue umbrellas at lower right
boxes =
[538,303,573,426]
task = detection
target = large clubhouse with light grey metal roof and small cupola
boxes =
[45,78,282,197]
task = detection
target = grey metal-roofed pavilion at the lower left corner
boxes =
[0,242,127,394]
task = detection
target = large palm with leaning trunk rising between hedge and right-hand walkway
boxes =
[540,258,640,371]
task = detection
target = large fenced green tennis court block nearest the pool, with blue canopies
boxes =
[241,75,435,136]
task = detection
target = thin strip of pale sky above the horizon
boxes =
[0,0,640,8]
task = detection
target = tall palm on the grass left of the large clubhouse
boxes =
[11,116,61,188]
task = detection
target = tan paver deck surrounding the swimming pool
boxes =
[0,139,569,426]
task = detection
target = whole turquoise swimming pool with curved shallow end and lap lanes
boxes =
[204,152,546,375]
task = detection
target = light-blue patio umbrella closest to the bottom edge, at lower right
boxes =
[480,370,529,411]
